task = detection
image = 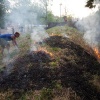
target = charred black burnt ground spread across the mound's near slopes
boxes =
[0,36,100,100]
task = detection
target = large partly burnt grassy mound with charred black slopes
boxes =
[0,26,100,100]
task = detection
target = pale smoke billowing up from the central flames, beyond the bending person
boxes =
[7,0,48,49]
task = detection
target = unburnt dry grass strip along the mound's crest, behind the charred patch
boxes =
[47,26,93,54]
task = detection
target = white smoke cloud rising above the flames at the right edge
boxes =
[76,4,100,47]
